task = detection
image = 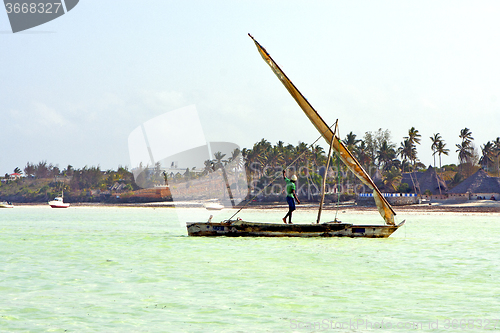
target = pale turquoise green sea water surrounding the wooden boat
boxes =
[0,207,500,332]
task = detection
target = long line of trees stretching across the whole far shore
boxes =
[0,127,500,201]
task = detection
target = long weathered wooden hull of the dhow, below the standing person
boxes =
[186,221,404,238]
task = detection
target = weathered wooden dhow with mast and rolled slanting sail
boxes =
[186,34,405,238]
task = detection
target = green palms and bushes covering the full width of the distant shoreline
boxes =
[0,127,500,202]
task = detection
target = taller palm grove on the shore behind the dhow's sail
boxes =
[238,127,500,192]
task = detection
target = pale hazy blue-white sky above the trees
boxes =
[0,0,500,174]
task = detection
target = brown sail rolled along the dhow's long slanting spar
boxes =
[248,34,396,225]
